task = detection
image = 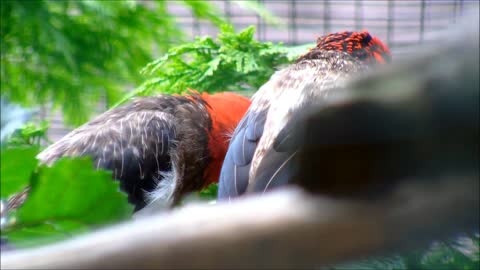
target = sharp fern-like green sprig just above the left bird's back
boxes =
[120,25,305,103]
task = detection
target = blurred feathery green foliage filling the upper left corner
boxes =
[0,0,223,124]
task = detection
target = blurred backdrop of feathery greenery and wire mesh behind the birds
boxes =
[2,0,478,141]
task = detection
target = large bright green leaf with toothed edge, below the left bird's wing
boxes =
[18,158,132,225]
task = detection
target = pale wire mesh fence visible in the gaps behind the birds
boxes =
[39,0,478,141]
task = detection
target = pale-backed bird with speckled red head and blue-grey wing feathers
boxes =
[218,30,392,201]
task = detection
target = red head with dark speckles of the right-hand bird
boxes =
[298,31,392,64]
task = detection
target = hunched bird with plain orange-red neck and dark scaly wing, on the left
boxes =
[37,90,250,212]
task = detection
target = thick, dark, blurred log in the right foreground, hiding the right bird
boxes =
[287,15,480,200]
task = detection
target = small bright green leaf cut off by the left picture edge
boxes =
[0,147,38,198]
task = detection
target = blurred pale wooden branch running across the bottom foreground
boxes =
[1,177,479,269]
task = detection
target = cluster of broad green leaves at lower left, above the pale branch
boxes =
[0,147,133,250]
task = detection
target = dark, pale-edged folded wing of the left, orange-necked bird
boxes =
[38,107,176,207]
